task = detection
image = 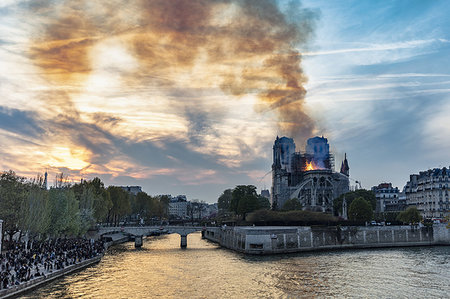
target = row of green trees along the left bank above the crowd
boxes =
[0,170,170,245]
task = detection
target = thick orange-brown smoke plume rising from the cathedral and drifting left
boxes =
[30,0,317,142]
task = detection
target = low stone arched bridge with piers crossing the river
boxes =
[98,225,206,248]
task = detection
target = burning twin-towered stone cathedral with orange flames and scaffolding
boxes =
[271,136,349,213]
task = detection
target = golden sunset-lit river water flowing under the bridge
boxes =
[25,233,450,298]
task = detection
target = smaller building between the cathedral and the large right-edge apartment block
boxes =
[372,183,406,213]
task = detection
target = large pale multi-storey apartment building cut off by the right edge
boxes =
[405,167,450,218]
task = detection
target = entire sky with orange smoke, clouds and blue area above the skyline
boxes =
[0,0,450,202]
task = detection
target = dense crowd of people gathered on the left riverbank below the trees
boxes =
[0,238,104,290]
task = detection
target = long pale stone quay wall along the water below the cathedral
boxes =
[204,224,450,254]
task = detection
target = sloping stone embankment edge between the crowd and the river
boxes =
[0,255,103,299]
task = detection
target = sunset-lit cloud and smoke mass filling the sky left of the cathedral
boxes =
[0,0,319,202]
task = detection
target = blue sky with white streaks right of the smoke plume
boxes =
[298,1,450,188]
